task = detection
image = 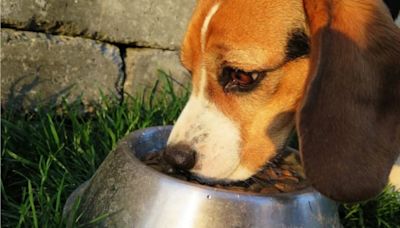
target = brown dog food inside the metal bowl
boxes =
[143,149,308,195]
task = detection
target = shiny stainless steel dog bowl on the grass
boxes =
[65,126,340,228]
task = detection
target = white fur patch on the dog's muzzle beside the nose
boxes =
[168,95,241,179]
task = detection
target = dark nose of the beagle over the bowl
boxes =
[164,145,196,170]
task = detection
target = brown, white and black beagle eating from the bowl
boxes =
[165,0,400,202]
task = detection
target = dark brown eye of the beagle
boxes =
[219,67,265,92]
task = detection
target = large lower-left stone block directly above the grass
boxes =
[1,29,124,109]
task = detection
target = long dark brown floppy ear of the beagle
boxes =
[297,0,400,202]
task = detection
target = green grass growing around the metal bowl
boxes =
[1,72,400,227]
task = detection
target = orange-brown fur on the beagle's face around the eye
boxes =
[182,0,308,172]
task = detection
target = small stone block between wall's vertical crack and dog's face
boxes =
[124,48,191,96]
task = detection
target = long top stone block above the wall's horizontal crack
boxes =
[1,0,196,49]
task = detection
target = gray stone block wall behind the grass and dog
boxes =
[1,0,196,109]
